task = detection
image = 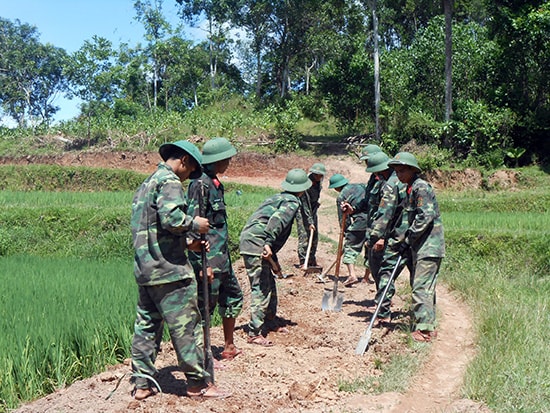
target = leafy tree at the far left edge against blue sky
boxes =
[0,18,66,127]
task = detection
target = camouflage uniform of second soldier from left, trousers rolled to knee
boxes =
[187,171,243,318]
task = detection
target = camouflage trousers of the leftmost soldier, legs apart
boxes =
[132,278,211,389]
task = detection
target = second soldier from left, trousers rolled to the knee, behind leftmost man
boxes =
[187,138,243,360]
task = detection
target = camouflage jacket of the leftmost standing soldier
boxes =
[131,162,201,286]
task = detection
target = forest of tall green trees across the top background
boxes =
[0,0,550,167]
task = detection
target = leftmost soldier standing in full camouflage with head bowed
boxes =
[131,141,229,400]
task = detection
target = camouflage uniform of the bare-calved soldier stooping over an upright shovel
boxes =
[336,184,367,264]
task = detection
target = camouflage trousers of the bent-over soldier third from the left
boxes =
[243,255,277,337]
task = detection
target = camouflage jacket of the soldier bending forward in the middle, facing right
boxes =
[240,192,301,256]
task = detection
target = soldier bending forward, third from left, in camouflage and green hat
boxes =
[240,169,311,346]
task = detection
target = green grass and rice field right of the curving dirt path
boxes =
[442,191,550,413]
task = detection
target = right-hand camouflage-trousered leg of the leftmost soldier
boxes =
[155,278,212,387]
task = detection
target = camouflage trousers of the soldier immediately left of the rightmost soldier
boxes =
[374,246,410,318]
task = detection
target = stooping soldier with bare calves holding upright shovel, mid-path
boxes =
[329,174,367,287]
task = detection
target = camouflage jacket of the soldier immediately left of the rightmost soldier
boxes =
[369,172,408,246]
